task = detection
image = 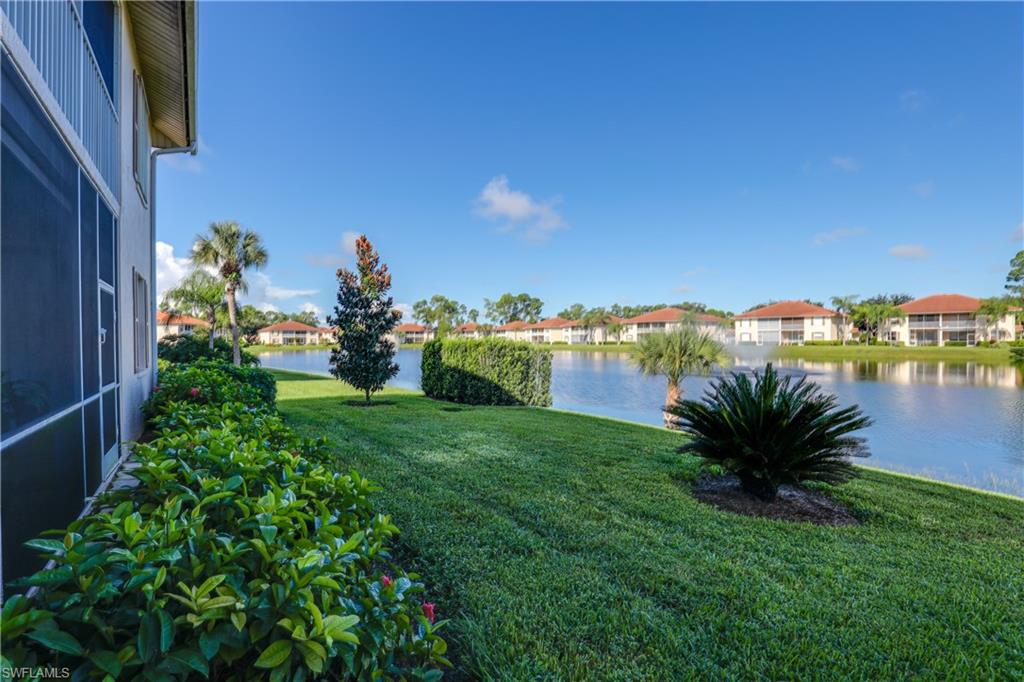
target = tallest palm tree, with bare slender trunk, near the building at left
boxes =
[191,220,266,365]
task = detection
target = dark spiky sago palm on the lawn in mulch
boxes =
[666,365,871,501]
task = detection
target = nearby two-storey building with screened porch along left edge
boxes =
[0,0,197,584]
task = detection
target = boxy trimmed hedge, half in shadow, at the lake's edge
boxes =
[422,338,551,408]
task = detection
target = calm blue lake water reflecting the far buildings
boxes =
[260,349,1024,497]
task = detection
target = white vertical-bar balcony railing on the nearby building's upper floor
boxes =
[0,0,120,198]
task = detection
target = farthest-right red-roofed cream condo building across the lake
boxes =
[883,294,1017,346]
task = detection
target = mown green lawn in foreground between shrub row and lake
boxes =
[275,372,1024,680]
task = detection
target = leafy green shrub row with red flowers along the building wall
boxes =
[0,352,447,681]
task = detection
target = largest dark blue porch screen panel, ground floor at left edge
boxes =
[0,53,82,436]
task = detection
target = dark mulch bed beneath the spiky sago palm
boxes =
[693,475,860,525]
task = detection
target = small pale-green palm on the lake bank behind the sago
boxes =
[633,326,728,428]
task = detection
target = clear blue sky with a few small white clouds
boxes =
[158,2,1024,314]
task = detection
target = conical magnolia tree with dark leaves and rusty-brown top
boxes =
[328,235,401,404]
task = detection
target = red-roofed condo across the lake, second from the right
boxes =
[733,301,848,346]
